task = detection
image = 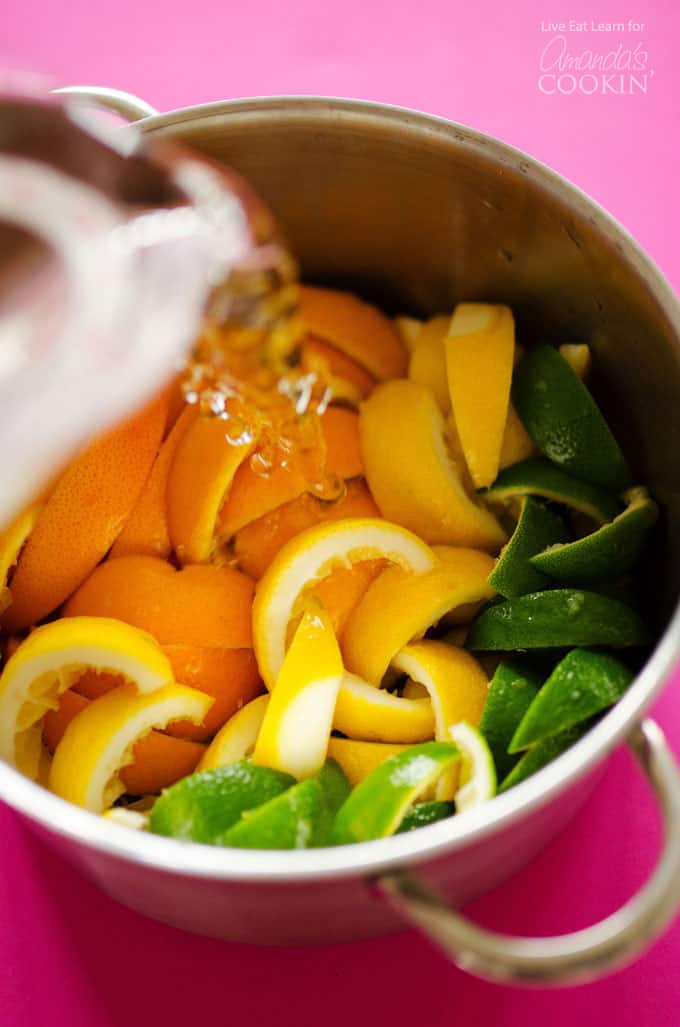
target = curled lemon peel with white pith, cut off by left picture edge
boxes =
[0,617,174,778]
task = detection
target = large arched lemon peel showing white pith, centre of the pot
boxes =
[253,518,436,689]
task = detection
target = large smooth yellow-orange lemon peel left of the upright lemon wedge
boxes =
[360,379,505,551]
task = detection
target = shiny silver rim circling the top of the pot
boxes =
[0,96,680,883]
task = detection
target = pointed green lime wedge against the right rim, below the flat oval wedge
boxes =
[507,649,633,753]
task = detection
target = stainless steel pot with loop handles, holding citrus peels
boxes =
[0,89,680,983]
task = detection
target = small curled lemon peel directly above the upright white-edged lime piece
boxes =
[392,639,489,741]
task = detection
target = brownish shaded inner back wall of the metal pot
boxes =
[143,99,680,631]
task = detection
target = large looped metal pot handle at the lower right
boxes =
[376,720,680,986]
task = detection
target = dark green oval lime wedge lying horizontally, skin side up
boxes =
[465,588,649,652]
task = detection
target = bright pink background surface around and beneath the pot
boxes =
[0,0,680,1027]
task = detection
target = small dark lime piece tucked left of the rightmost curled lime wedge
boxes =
[487,496,569,599]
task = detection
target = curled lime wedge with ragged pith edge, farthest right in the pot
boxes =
[534,487,658,591]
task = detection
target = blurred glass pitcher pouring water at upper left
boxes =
[0,98,294,526]
